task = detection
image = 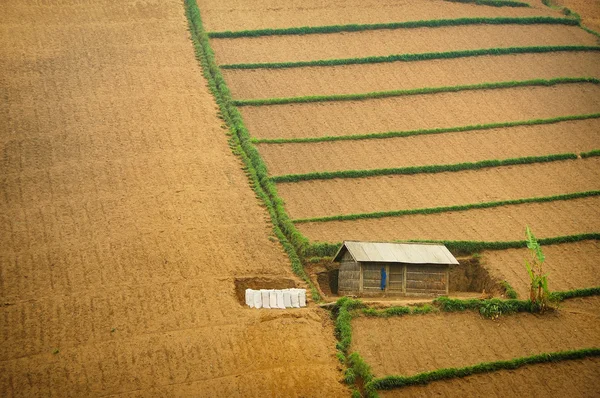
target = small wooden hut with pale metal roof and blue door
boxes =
[333,241,458,296]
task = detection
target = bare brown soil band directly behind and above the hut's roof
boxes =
[297,197,600,242]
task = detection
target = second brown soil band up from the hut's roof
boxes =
[277,158,600,218]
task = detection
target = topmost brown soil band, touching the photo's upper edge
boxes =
[198,0,560,31]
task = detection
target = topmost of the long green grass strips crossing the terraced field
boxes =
[208,17,579,39]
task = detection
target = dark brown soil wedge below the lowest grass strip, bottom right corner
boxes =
[379,358,600,398]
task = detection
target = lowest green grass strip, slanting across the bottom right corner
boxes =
[366,348,600,393]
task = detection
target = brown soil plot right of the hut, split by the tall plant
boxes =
[481,241,600,298]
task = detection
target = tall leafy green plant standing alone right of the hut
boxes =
[525,226,551,313]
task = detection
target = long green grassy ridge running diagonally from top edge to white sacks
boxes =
[184,0,320,300]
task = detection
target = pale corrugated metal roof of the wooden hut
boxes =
[334,241,458,264]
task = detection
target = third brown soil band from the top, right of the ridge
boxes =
[223,52,600,99]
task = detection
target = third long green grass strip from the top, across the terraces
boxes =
[233,77,600,106]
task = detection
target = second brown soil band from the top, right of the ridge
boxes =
[211,25,598,64]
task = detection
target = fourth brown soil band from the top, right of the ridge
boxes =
[241,83,600,138]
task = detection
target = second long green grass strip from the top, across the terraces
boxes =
[221,45,600,69]
